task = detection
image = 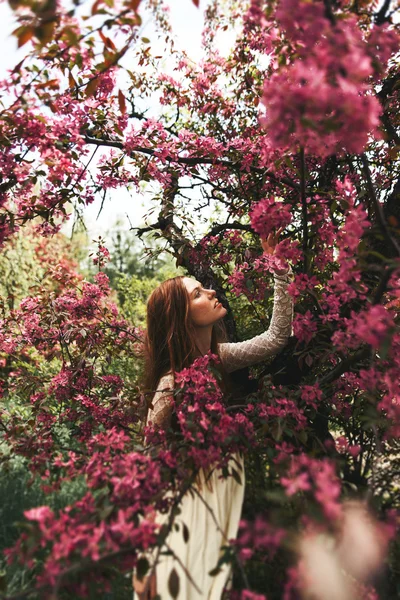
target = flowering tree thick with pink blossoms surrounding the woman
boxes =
[0,0,400,599]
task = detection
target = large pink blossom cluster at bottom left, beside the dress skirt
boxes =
[7,428,164,588]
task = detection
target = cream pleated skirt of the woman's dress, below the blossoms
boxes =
[152,454,245,600]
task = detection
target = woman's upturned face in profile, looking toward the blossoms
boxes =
[183,277,227,327]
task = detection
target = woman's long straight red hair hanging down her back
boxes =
[144,276,225,394]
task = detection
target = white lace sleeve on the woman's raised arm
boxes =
[218,268,293,373]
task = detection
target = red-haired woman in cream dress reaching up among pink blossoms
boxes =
[134,230,293,600]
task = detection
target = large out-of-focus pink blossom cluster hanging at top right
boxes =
[261,0,394,156]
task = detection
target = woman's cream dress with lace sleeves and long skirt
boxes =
[147,270,293,600]
